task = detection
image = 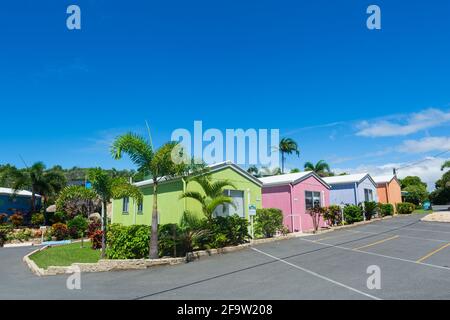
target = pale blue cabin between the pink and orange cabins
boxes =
[323,173,378,205]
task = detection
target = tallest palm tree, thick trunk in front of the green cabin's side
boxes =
[111,133,186,259]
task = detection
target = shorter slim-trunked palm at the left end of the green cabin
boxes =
[88,168,142,258]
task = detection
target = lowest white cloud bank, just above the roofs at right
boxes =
[334,157,447,191]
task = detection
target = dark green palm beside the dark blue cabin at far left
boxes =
[0,162,67,212]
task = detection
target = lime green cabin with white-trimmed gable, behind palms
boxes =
[111,161,262,225]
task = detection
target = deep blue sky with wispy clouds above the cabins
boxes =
[0,0,450,188]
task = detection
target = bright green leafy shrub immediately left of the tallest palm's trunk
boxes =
[106,224,150,259]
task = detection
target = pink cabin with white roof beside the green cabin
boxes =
[260,172,330,232]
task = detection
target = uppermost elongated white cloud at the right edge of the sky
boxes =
[356,108,450,137]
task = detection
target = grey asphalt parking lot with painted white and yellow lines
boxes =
[0,215,450,300]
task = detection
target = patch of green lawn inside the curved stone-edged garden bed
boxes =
[30,242,100,269]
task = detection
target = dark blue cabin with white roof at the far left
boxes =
[0,188,41,215]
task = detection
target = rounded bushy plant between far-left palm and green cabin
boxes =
[56,186,101,218]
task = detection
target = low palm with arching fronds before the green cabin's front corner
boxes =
[180,175,236,222]
